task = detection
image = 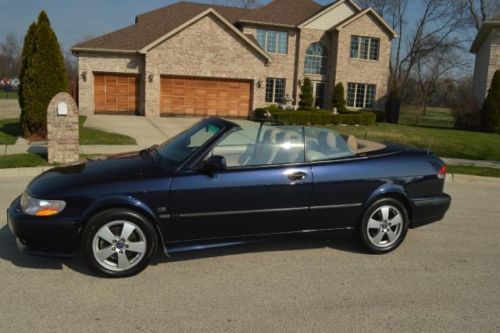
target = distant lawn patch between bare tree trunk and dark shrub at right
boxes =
[399,105,455,128]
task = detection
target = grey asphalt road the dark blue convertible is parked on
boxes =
[0,172,500,332]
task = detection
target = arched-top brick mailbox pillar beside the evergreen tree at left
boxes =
[47,92,80,163]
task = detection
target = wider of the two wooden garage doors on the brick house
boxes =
[160,77,251,118]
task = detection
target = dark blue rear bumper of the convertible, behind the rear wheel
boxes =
[410,193,451,229]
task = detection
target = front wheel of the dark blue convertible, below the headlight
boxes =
[82,208,158,278]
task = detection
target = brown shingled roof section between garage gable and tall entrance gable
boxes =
[239,0,329,27]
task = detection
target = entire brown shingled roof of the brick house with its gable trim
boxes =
[71,0,397,53]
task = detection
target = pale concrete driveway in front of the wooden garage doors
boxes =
[85,115,201,147]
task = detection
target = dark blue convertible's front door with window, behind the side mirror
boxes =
[168,125,312,241]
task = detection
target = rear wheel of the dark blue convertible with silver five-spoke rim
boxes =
[359,198,409,254]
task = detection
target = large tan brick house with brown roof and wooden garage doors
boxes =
[72,0,397,117]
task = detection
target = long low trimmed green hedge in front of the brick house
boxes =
[255,109,376,126]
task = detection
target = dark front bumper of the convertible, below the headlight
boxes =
[7,197,79,256]
